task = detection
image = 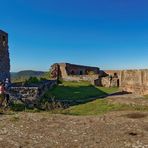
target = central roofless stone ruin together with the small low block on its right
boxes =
[51,63,119,87]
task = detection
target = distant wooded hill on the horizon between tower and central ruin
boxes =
[11,70,47,82]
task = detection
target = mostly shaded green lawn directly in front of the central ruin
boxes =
[45,82,118,100]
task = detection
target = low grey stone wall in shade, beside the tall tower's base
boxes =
[10,80,57,100]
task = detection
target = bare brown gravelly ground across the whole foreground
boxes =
[0,111,148,148]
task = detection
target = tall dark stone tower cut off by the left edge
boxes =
[0,30,10,81]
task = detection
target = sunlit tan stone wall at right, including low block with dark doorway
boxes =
[101,69,148,95]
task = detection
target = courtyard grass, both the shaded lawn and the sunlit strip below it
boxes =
[41,81,148,115]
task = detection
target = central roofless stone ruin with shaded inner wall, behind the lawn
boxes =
[51,63,102,85]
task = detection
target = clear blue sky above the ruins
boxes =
[0,0,148,71]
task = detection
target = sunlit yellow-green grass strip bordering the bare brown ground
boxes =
[62,99,148,115]
